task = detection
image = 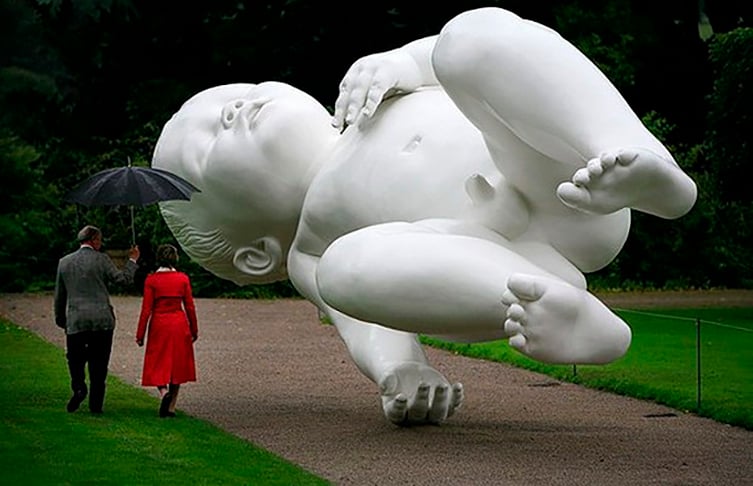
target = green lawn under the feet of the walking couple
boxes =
[0,320,328,485]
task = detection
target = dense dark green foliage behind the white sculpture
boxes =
[0,0,753,295]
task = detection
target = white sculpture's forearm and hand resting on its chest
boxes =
[332,36,439,130]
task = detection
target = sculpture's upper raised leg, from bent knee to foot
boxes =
[432,8,696,218]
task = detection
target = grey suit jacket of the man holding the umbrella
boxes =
[54,246,138,334]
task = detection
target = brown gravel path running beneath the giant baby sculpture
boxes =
[0,291,753,486]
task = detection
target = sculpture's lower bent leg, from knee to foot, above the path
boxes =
[317,223,629,363]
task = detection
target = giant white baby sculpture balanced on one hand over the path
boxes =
[153,8,696,424]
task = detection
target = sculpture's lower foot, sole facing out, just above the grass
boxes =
[502,273,631,364]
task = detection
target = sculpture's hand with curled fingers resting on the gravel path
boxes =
[379,362,464,425]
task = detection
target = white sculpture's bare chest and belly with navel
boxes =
[296,90,498,252]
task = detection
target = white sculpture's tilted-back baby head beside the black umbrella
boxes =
[152,82,337,285]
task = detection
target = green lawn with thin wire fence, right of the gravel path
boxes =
[422,308,753,430]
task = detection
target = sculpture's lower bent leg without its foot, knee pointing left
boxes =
[316,223,550,335]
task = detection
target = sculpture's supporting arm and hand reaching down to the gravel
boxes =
[288,249,463,425]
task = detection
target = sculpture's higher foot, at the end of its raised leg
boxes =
[557,148,697,219]
